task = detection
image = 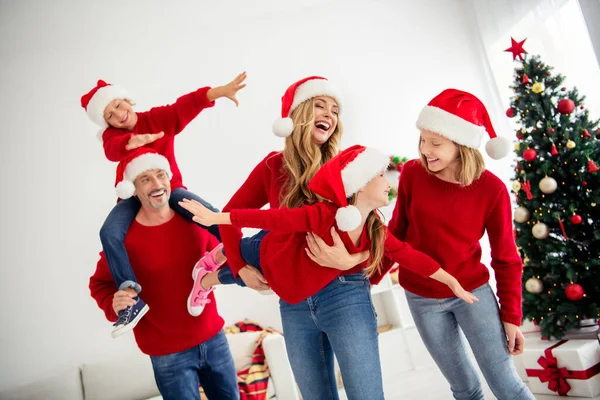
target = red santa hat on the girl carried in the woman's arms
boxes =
[308,145,390,232]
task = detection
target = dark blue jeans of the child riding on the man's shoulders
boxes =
[100,188,221,293]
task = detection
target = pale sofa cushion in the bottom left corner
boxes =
[0,368,83,400]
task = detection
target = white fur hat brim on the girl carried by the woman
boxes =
[342,147,390,197]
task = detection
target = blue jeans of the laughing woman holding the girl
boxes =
[279,273,384,400]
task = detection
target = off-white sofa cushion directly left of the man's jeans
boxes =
[81,351,160,400]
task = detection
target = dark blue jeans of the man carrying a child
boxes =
[150,330,240,400]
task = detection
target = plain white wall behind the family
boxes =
[0,0,501,390]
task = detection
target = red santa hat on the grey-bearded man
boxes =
[115,147,173,199]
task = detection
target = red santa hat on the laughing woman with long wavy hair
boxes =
[273,76,342,137]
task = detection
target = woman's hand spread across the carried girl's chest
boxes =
[306,227,369,271]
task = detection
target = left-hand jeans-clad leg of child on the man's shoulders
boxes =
[100,197,142,293]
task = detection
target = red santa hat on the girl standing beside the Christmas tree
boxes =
[417,89,510,160]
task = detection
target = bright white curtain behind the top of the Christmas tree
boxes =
[464,0,600,123]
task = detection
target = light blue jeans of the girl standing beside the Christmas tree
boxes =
[406,283,535,400]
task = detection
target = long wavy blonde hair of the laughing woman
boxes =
[280,98,343,208]
